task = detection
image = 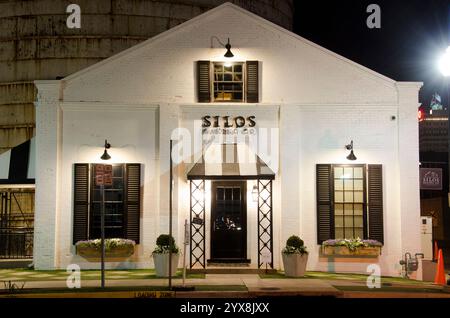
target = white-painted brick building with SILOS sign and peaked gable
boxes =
[34,4,421,275]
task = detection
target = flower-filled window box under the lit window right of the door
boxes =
[322,238,383,257]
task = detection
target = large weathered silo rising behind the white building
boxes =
[0,0,294,153]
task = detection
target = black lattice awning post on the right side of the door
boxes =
[258,180,273,268]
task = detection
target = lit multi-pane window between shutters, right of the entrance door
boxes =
[333,166,366,239]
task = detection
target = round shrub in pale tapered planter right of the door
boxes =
[282,236,308,277]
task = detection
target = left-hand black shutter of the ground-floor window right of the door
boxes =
[316,165,334,244]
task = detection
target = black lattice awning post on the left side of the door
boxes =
[190,180,206,268]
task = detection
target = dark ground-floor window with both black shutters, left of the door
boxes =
[73,164,141,243]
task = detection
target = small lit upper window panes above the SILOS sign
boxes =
[213,63,244,102]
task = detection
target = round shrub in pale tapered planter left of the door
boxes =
[152,234,180,277]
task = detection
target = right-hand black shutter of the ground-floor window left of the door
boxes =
[125,164,141,244]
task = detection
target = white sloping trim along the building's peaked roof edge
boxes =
[63,2,396,85]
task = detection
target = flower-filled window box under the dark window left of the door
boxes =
[75,238,136,258]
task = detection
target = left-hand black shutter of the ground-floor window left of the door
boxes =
[73,164,89,244]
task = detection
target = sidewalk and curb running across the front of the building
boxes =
[0,274,450,298]
